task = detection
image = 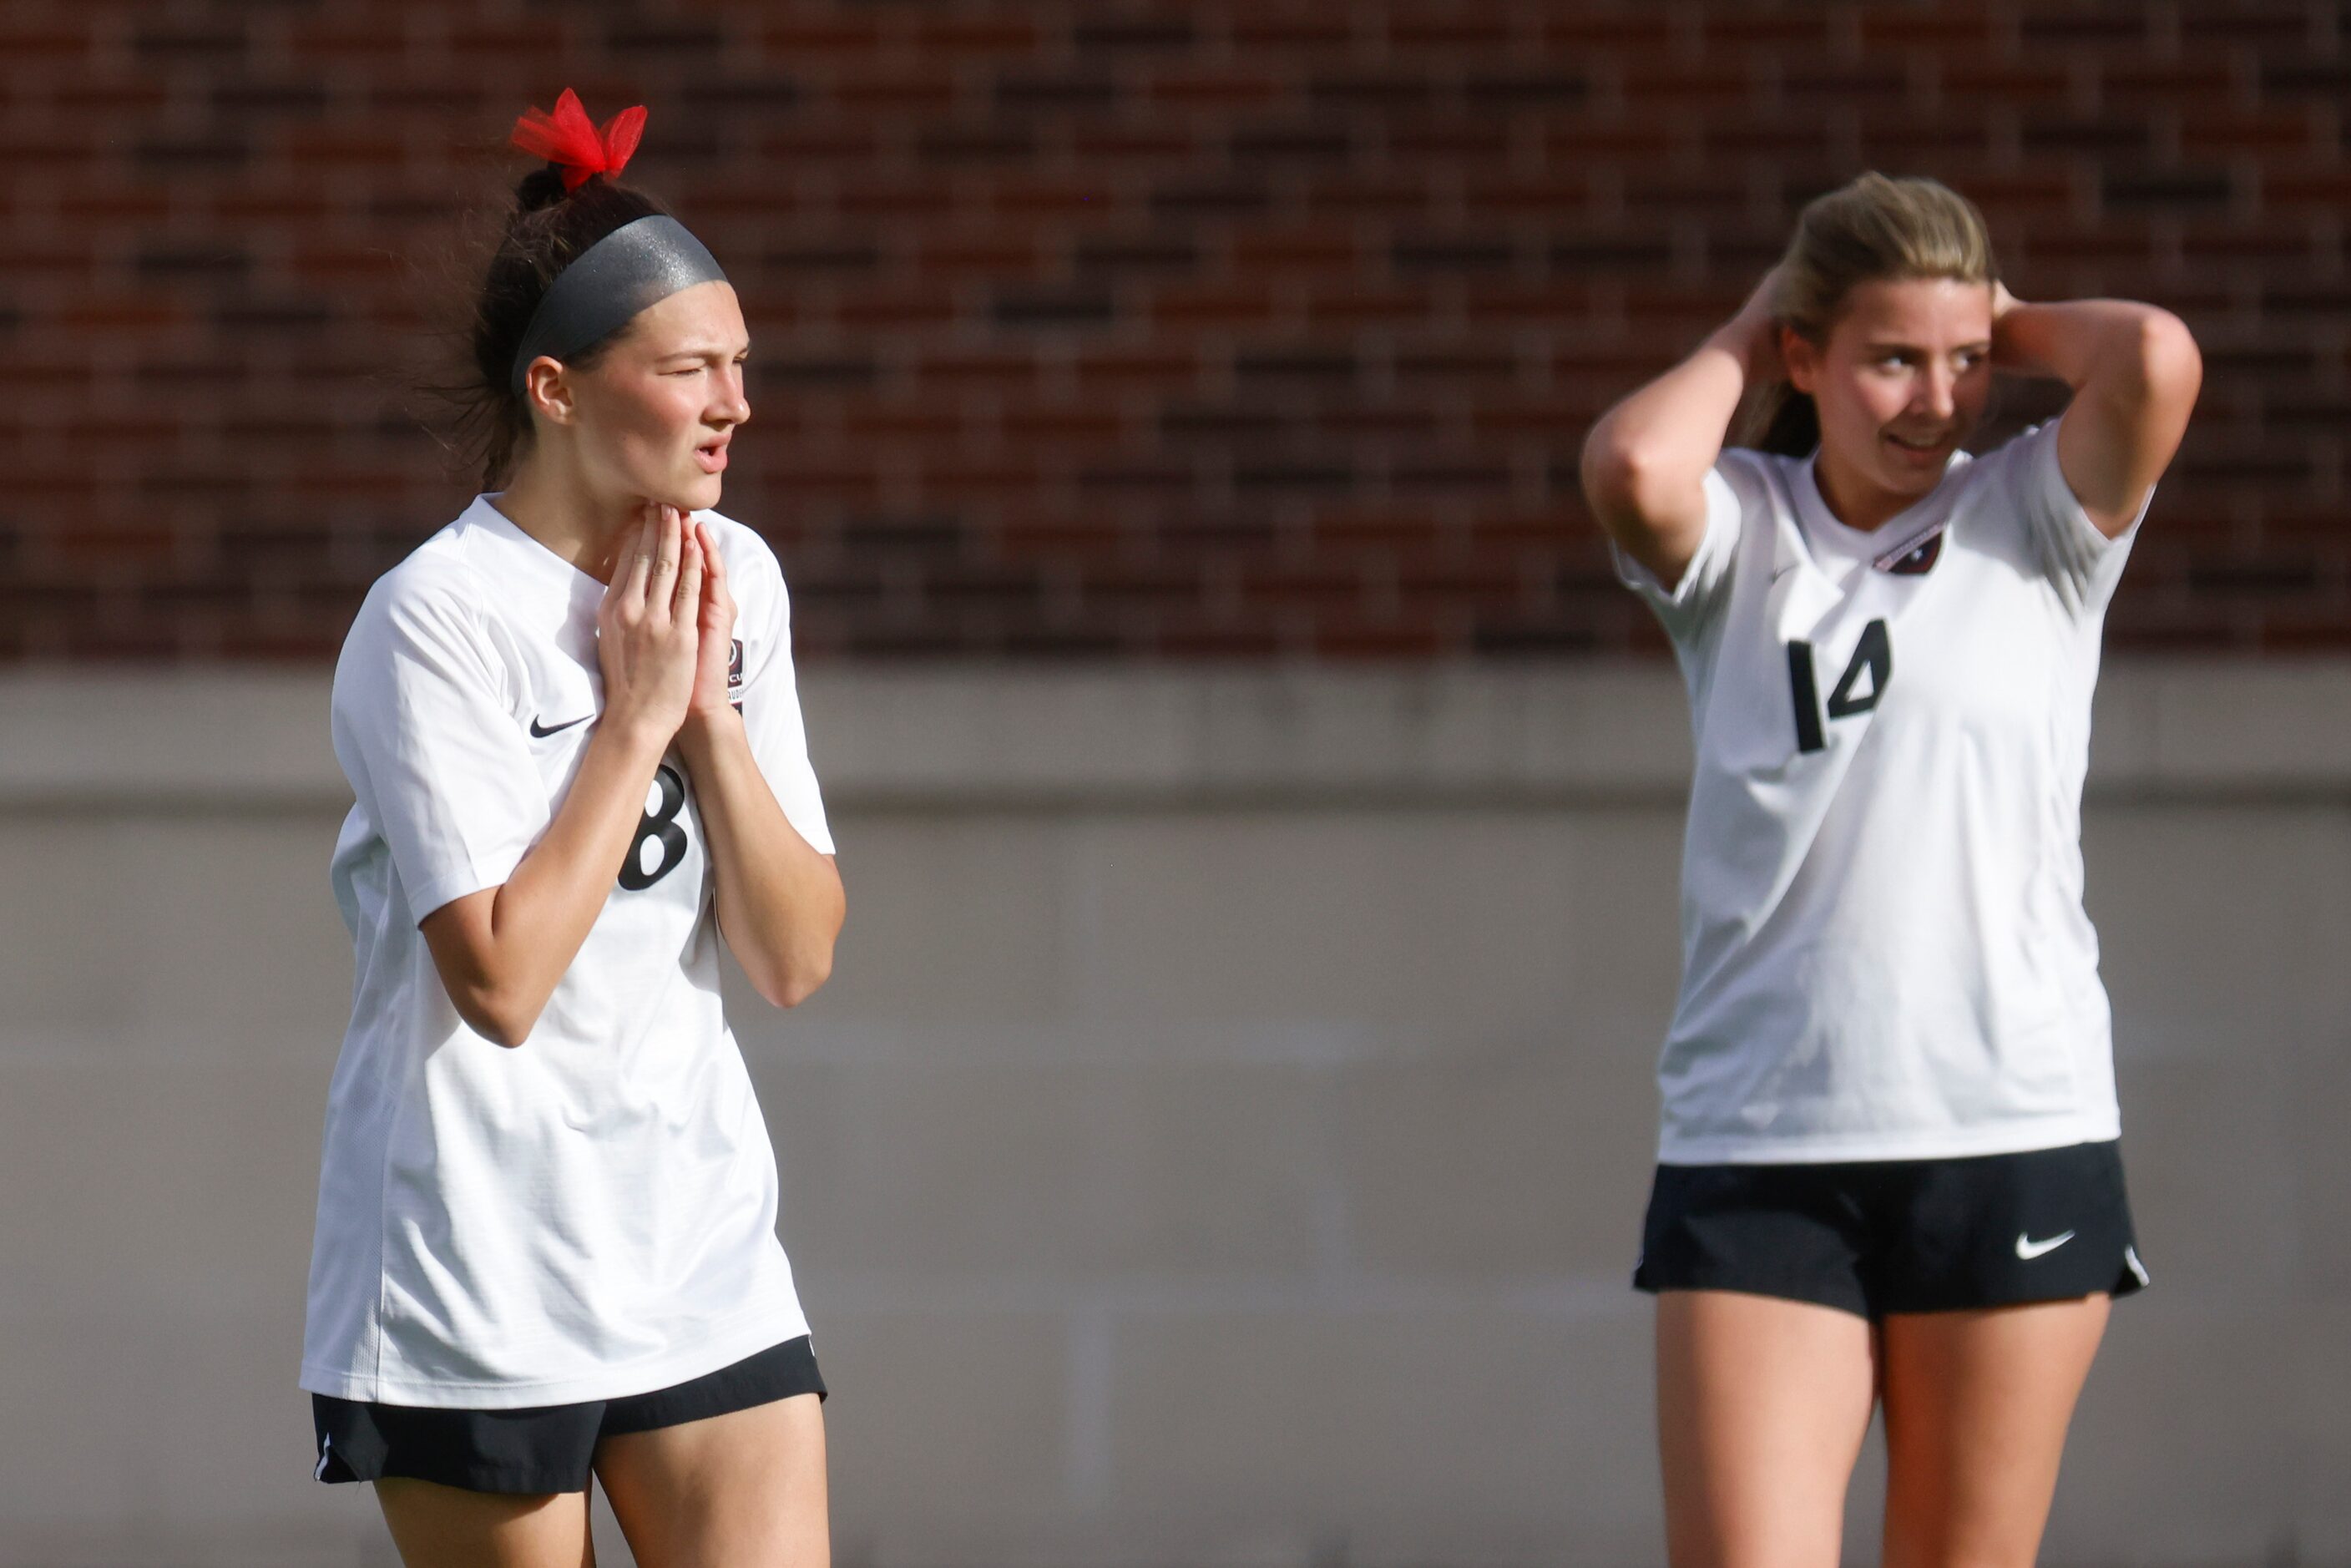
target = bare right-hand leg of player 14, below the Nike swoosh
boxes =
[1883,1295,2111,1568]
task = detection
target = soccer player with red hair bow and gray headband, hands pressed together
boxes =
[301,89,842,1568]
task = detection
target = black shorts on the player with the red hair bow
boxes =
[311,1335,825,1493]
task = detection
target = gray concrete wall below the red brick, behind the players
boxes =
[0,665,2351,1568]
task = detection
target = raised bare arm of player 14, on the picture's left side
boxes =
[1582,277,1780,588]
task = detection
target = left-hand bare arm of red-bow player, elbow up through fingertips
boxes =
[418,508,703,1046]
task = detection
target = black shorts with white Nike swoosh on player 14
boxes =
[1631,1142,2146,1319]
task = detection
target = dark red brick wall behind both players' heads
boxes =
[0,0,2351,660]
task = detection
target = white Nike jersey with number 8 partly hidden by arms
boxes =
[301,496,832,1409]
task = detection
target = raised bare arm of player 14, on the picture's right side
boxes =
[1991,287,2203,539]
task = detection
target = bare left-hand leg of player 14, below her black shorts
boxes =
[1657,1291,1876,1568]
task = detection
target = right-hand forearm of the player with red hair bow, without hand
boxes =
[677,707,844,1006]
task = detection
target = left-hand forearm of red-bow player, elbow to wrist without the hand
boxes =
[426,720,663,1046]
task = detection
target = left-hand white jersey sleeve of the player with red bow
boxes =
[334,585,548,922]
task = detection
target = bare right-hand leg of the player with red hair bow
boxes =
[594,1394,832,1568]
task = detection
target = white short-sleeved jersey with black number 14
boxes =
[1620,423,2137,1164]
